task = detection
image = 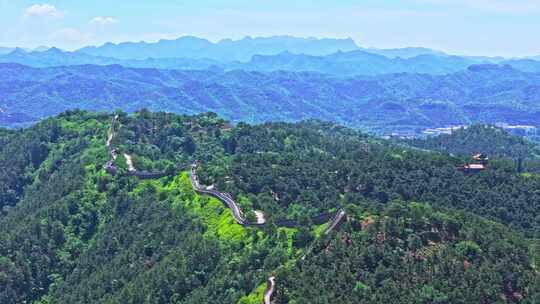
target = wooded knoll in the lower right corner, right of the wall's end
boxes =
[277,203,540,304]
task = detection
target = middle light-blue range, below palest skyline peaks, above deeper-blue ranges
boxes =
[0,48,540,77]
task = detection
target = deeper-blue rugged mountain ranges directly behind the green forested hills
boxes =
[0,64,540,132]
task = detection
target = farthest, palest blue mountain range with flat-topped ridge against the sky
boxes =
[0,36,464,66]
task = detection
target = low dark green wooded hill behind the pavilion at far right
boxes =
[405,125,540,158]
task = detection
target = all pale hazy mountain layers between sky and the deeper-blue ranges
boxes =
[0,36,540,76]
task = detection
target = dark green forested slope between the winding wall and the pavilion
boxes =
[205,121,540,236]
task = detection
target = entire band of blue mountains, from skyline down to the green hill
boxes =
[0,36,540,132]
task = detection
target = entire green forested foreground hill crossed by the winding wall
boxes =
[0,111,540,304]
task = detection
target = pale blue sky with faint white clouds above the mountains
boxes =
[0,0,540,57]
